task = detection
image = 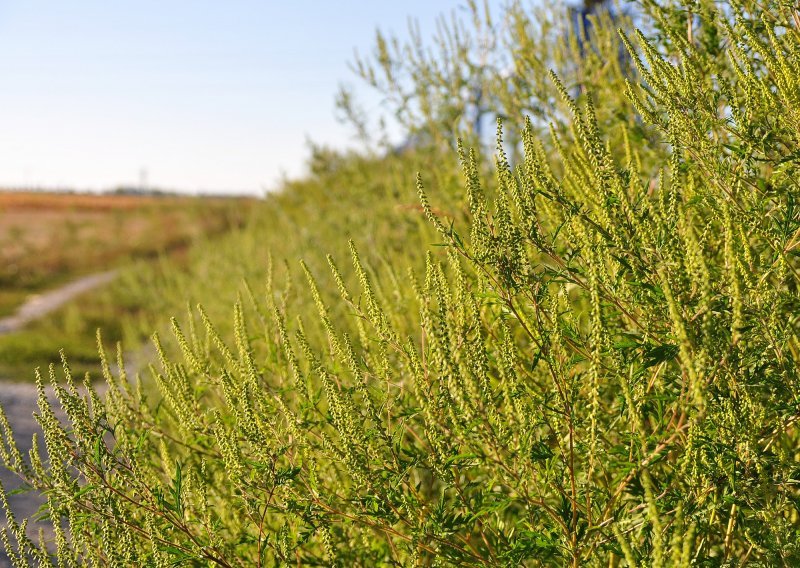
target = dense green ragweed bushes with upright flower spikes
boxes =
[1,0,800,566]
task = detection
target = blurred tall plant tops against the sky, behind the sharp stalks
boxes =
[346,0,631,156]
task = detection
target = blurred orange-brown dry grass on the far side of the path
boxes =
[0,192,254,314]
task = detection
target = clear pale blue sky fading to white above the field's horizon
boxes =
[0,0,500,193]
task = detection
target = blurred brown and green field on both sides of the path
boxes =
[0,192,259,380]
